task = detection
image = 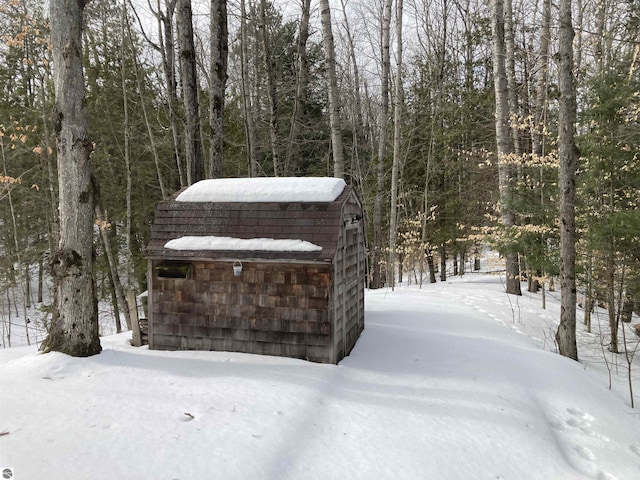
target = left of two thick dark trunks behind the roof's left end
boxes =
[176,0,204,184]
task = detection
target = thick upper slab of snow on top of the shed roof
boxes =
[176,177,346,202]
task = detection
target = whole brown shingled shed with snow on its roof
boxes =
[147,177,365,363]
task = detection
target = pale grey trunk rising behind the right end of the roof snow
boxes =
[320,0,344,178]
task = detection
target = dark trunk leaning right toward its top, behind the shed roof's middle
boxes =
[284,0,311,175]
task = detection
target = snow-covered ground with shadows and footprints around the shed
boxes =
[0,274,640,480]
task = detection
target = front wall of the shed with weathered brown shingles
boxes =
[149,259,336,363]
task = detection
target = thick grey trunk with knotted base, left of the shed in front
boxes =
[42,0,101,356]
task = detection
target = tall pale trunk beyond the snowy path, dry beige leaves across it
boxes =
[492,0,521,295]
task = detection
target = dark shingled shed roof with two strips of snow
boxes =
[147,177,357,262]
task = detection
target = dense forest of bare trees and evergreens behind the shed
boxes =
[0,0,640,358]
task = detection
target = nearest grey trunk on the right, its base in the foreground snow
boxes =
[556,0,578,360]
